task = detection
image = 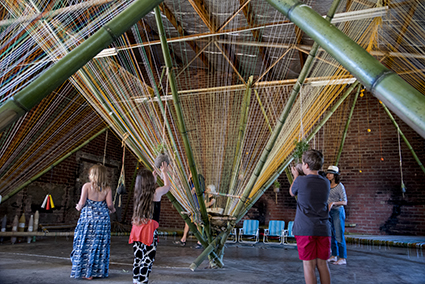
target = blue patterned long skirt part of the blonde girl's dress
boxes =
[71,199,111,278]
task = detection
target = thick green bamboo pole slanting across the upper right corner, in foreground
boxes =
[267,0,425,138]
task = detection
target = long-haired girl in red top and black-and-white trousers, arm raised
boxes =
[128,162,171,284]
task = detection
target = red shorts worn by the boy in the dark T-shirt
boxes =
[295,236,331,260]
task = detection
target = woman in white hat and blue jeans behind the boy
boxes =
[326,166,347,265]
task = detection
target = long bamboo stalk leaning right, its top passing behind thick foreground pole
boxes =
[227,0,340,220]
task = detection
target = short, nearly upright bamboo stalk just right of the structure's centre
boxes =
[226,76,254,207]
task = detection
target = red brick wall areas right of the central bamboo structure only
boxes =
[255,93,425,235]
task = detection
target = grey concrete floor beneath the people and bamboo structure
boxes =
[0,236,425,284]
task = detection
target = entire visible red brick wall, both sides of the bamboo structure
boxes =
[4,88,425,235]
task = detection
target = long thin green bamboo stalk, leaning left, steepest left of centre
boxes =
[154,7,212,241]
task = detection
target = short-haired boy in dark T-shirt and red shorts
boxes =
[289,150,331,284]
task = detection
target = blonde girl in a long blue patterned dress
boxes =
[71,165,115,280]
